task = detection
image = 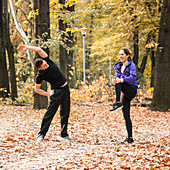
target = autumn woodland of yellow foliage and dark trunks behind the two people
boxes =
[0,0,169,111]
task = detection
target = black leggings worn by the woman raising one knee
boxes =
[115,83,137,138]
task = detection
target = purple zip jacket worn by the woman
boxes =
[113,61,138,87]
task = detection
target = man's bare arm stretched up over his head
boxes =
[18,45,48,58]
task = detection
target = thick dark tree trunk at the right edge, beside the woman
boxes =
[152,0,170,111]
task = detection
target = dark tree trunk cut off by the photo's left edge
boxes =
[0,1,9,98]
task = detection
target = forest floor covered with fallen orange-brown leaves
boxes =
[0,103,170,170]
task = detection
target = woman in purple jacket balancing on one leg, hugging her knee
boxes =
[110,49,138,143]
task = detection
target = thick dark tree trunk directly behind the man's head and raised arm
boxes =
[34,0,50,109]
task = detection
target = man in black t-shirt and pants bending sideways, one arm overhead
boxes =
[18,45,72,142]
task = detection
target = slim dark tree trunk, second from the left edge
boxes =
[3,0,17,100]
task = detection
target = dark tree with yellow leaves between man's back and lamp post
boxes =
[59,0,74,86]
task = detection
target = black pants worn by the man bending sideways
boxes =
[39,85,70,137]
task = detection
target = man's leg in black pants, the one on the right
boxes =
[60,85,70,137]
